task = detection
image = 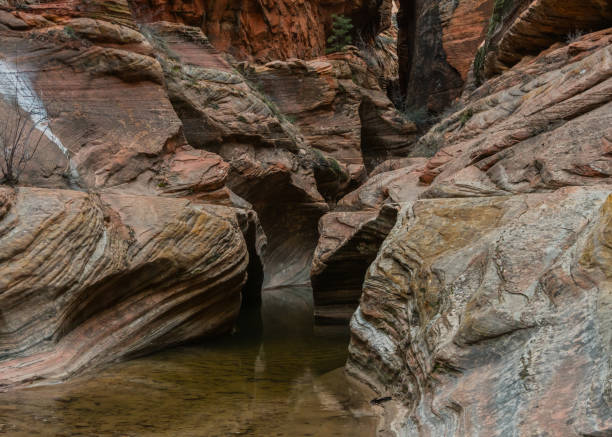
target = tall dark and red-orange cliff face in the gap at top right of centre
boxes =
[398,0,493,112]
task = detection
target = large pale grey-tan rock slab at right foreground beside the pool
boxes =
[348,187,612,436]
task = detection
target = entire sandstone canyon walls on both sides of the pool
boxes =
[0,0,612,437]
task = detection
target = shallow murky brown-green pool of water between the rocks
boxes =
[0,288,375,437]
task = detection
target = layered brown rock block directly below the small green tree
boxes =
[247,50,416,175]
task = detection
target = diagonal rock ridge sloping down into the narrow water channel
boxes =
[145,22,334,288]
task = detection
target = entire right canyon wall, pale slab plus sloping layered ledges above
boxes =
[340,6,612,436]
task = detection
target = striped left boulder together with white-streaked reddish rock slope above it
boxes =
[0,2,265,386]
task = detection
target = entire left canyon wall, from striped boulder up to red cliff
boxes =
[0,0,406,388]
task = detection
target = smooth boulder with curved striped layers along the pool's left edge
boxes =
[0,188,248,387]
